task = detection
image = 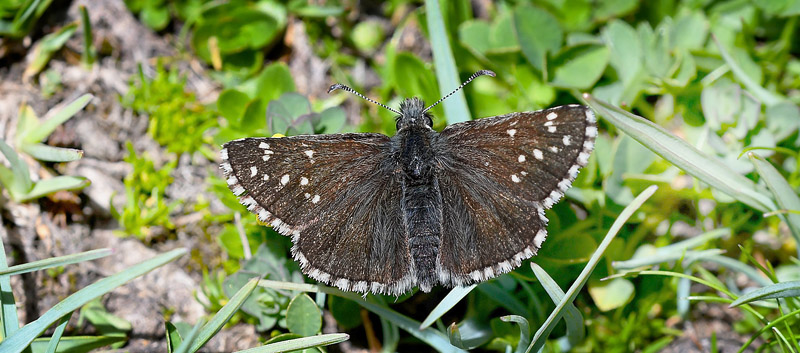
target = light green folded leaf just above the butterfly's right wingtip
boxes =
[549,44,609,90]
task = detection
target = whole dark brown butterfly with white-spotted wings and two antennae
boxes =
[221,70,597,296]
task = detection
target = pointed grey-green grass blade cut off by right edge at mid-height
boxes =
[747,152,800,254]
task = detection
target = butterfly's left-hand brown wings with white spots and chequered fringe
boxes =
[222,134,413,294]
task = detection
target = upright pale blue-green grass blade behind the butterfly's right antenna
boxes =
[425,0,472,124]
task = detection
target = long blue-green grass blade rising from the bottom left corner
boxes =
[0,248,186,353]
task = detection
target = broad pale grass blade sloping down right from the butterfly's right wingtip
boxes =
[583,94,774,212]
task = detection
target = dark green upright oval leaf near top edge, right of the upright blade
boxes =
[514,5,564,73]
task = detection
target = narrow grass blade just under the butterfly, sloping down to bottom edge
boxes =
[331,291,464,352]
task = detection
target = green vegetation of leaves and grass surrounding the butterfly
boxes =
[0,0,800,353]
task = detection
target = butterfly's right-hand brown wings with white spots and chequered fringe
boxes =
[439,105,597,285]
